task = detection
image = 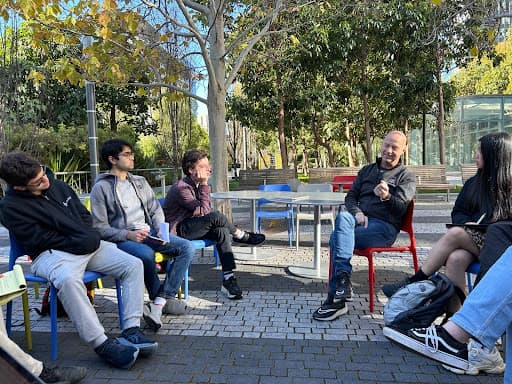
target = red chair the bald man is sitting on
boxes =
[329,200,419,312]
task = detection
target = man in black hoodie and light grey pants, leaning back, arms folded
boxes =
[0,152,158,368]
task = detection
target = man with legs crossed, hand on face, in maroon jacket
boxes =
[164,150,265,299]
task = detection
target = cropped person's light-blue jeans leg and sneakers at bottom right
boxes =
[384,247,512,376]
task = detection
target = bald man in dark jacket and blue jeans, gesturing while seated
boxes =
[313,131,416,321]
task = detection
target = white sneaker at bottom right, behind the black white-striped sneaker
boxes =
[443,339,505,375]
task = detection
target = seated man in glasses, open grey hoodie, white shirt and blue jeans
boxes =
[90,139,195,331]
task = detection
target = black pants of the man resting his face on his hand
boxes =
[176,211,237,271]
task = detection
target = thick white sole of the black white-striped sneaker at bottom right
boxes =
[383,327,469,371]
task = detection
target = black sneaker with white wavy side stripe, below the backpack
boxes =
[384,325,469,371]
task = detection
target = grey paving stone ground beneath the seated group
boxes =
[0,201,503,384]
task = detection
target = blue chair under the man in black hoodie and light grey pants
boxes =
[5,234,124,360]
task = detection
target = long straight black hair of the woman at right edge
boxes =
[468,132,512,221]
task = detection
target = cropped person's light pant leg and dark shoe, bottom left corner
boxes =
[0,286,87,384]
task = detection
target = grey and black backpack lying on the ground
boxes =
[384,273,465,330]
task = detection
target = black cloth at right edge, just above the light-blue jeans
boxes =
[475,221,512,284]
